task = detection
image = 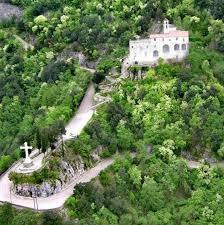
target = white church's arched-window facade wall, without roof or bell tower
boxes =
[129,36,189,65]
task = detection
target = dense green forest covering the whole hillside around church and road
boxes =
[0,0,224,225]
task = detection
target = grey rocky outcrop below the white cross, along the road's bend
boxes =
[14,157,85,198]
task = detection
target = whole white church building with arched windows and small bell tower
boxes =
[126,19,189,66]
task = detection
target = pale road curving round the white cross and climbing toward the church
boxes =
[0,84,113,210]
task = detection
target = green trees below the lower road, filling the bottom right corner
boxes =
[66,153,224,225]
